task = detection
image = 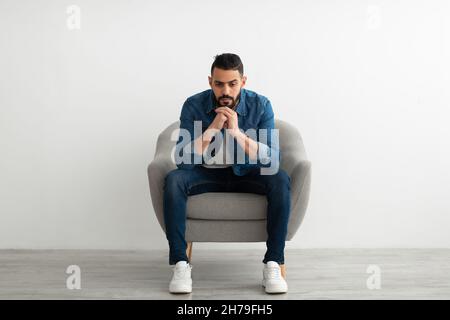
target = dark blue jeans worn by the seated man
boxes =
[163,166,291,265]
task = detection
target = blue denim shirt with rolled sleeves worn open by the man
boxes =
[175,89,280,176]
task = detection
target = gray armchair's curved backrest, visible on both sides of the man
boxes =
[155,119,306,169]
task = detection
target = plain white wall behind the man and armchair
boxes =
[0,0,450,249]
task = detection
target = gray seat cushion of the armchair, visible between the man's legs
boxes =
[186,192,267,220]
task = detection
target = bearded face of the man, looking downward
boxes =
[208,68,247,109]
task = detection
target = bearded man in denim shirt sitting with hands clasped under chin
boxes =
[164,53,291,293]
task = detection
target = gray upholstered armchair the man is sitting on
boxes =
[148,119,311,270]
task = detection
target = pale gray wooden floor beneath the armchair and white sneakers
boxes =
[0,249,450,300]
